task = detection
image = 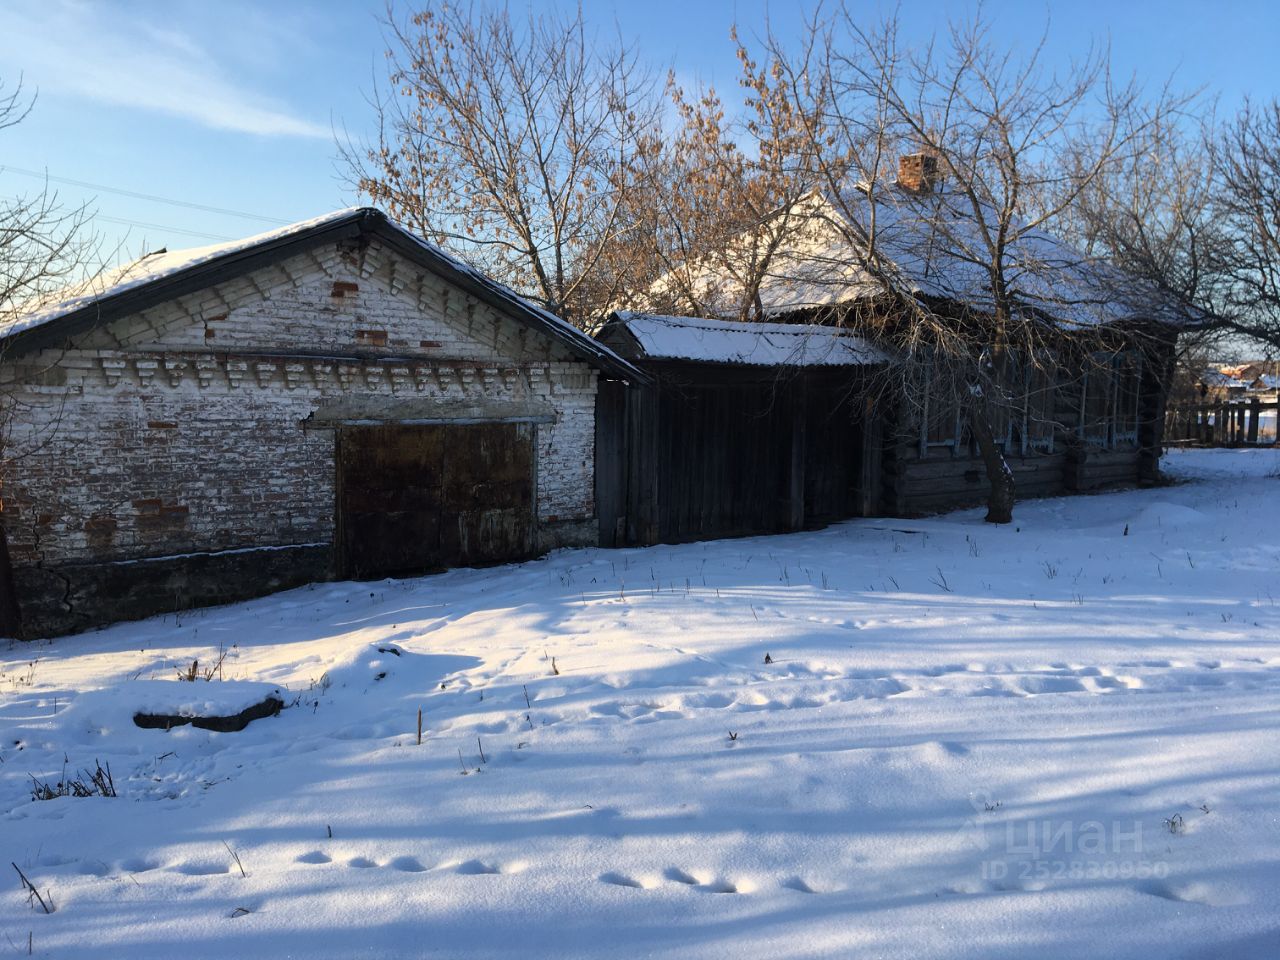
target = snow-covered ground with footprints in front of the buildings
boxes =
[0,451,1280,960]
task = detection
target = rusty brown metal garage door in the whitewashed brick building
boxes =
[338,424,534,579]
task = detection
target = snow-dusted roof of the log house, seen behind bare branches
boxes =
[654,182,1197,329]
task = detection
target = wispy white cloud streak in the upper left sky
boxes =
[0,0,332,138]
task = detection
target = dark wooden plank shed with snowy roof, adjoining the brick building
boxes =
[598,312,884,545]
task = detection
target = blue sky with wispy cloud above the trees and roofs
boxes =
[0,0,1280,261]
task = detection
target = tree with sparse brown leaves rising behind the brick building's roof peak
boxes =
[339,3,657,323]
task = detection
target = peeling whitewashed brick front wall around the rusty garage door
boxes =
[3,244,595,564]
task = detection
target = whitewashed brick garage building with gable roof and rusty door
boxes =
[0,209,643,635]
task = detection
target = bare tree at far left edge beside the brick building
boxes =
[0,78,97,636]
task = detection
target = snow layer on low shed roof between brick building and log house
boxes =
[614,312,887,366]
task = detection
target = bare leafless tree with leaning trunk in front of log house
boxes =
[742,6,1167,524]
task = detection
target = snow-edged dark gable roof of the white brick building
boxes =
[0,207,648,380]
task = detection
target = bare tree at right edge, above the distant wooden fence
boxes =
[1068,101,1280,375]
